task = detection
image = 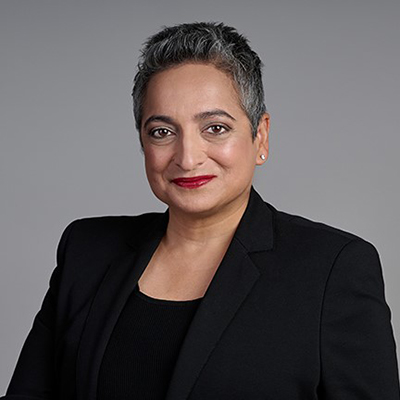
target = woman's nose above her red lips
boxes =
[174,132,207,171]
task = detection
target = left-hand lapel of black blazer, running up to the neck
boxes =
[76,213,168,400]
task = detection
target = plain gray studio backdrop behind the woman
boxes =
[0,0,400,393]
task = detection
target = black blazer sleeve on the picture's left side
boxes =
[1,222,74,400]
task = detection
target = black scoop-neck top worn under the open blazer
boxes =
[97,285,201,400]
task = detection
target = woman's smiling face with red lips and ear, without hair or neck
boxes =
[141,64,269,219]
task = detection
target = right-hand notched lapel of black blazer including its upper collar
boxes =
[166,189,273,400]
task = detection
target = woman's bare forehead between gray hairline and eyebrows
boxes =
[143,64,245,117]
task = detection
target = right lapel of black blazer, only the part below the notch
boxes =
[166,240,260,400]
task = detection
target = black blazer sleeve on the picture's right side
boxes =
[320,239,400,400]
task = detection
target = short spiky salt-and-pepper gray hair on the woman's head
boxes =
[132,22,266,138]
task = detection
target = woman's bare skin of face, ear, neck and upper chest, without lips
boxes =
[139,64,269,300]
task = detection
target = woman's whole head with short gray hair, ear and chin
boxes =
[133,23,269,216]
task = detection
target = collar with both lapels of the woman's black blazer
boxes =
[77,188,274,400]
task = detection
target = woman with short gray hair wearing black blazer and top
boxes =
[5,23,400,400]
